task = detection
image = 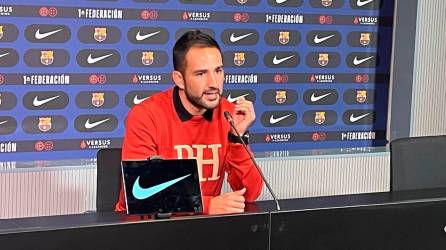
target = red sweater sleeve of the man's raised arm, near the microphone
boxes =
[226,143,263,202]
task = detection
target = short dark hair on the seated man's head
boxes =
[172,30,221,73]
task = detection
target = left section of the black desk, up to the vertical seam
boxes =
[0,213,269,250]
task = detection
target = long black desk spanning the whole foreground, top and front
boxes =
[0,189,446,250]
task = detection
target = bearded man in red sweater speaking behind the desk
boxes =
[115,28,263,214]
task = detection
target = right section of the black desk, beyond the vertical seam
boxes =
[270,189,446,250]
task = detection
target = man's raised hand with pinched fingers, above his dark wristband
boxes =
[231,97,256,135]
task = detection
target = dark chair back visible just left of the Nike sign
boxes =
[96,148,121,212]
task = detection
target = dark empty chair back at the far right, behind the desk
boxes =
[390,135,446,191]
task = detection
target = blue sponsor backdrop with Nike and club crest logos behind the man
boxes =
[0,0,394,160]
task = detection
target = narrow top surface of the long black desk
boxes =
[0,188,446,234]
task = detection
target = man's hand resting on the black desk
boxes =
[209,188,246,214]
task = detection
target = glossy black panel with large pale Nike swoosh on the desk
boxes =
[121,159,203,215]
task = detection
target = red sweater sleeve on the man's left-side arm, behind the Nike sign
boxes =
[115,105,158,212]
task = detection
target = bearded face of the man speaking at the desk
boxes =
[182,47,224,115]
